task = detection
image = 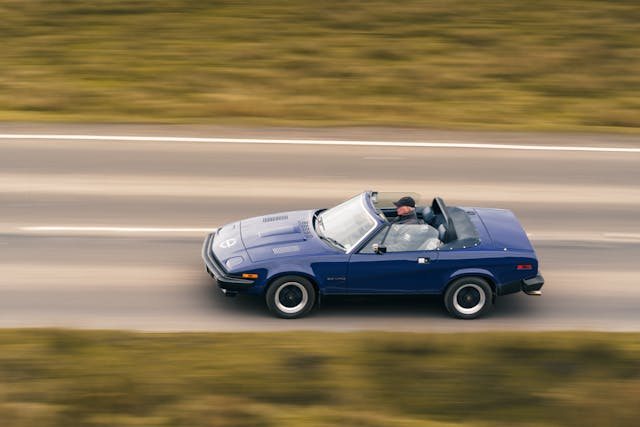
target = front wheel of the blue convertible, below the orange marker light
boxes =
[265,276,316,319]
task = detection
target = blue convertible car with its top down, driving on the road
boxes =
[202,191,544,319]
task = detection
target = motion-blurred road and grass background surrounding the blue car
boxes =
[0,0,640,427]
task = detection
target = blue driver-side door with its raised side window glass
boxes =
[347,224,440,294]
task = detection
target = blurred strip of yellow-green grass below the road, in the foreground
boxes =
[0,330,640,427]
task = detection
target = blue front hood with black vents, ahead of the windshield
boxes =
[240,210,335,262]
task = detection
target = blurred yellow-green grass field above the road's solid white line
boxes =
[0,0,640,132]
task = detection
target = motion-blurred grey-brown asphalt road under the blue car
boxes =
[0,125,640,331]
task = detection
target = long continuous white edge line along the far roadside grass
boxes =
[0,134,640,153]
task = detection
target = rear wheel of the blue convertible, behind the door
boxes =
[444,277,493,319]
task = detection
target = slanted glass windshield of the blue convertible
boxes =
[316,194,376,252]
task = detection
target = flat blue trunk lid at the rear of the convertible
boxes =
[474,208,533,251]
